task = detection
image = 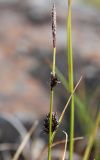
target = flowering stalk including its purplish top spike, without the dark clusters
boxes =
[48,4,56,160]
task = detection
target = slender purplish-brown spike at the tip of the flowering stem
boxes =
[52,3,57,48]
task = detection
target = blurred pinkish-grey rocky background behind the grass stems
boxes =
[0,0,100,160]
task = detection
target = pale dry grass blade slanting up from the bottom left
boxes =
[12,121,38,160]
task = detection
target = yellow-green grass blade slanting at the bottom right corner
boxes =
[83,112,100,160]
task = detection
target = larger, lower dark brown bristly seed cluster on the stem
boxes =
[44,112,58,133]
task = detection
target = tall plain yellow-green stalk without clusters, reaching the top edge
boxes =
[67,0,74,160]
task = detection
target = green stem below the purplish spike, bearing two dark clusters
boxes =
[48,48,56,160]
